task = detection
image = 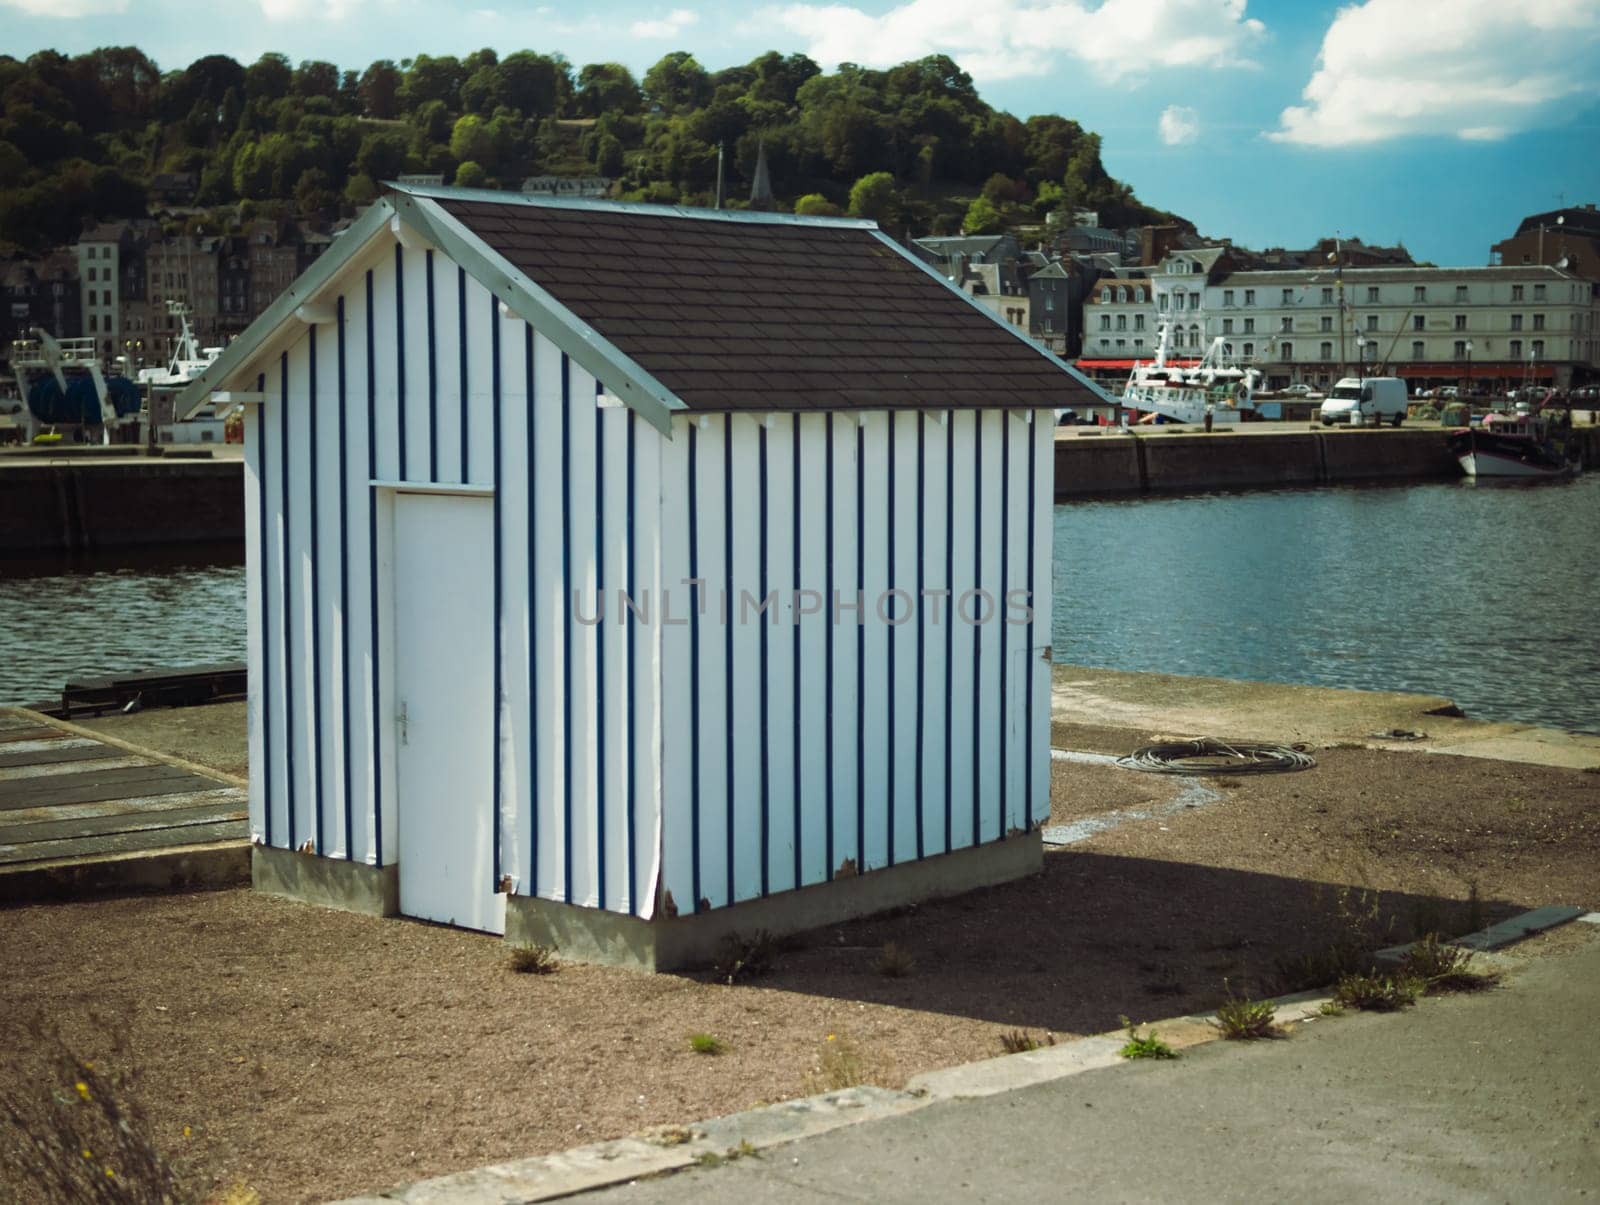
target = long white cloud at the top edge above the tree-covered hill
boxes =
[757,0,1266,82]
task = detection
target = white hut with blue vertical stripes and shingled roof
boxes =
[181,187,1091,967]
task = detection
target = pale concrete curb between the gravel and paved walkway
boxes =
[330,906,1600,1205]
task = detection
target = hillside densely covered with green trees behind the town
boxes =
[0,46,1187,251]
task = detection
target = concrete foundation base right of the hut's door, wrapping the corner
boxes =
[506,832,1045,971]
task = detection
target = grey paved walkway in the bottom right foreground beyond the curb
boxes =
[584,923,1600,1205]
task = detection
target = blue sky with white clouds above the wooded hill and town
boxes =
[0,0,1600,264]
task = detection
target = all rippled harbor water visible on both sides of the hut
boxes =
[0,474,1600,733]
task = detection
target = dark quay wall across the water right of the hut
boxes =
[1056,424,1600,501]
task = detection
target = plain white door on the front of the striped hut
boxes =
[394,493,506,933]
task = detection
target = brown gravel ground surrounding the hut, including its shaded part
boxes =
[0,706,1600,1202]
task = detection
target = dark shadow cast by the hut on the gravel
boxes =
[672,851,1510,1034]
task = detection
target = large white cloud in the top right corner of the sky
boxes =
[1267,0,1600,147]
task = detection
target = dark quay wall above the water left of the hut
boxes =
[0,458,245,557]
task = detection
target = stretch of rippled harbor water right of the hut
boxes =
[1053,474,1600,733]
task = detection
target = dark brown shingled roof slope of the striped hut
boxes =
[432,194,1088,411]
